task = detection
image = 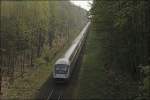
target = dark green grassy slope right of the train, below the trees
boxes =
[74,29,138,100]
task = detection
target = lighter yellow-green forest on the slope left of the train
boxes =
[0,0,87,97]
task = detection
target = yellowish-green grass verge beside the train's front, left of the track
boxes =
[7,44,69,99]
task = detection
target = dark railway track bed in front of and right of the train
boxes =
[37,31,86,100]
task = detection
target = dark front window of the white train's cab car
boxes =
[55,64,68,74]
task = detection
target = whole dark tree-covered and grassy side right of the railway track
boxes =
[74,0,150,100]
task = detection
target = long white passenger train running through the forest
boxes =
[53,22,91,81]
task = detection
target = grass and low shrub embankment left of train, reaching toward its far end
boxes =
[4,23,84,99]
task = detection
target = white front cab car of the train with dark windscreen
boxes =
[53,58,70,82]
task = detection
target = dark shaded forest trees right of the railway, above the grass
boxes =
[91,0,150,100]
